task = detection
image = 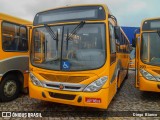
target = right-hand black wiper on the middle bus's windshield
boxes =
[66,21,85,50]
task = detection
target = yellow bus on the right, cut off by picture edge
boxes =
[136,18,160,92]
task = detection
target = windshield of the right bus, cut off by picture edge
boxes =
[141,32,160,66]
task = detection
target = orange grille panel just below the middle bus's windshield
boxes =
[40,73,89,83]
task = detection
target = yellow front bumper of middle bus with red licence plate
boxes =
[29,81,109,109]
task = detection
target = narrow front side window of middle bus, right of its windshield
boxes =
[109,24,116,53]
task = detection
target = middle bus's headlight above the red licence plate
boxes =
[83,76,108,92]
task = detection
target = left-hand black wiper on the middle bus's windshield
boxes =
[44,24,58,52]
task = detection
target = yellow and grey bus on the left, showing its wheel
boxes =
[0,13,31,102]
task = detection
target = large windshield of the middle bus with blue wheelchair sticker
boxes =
[31,23,106,71]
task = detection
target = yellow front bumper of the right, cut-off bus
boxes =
[139,77,160,92]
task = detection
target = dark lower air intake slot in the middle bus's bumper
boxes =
[49,92,76,100]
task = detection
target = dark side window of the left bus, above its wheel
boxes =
[2,22,28,52]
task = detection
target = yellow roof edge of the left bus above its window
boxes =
[0,13,32,25]
